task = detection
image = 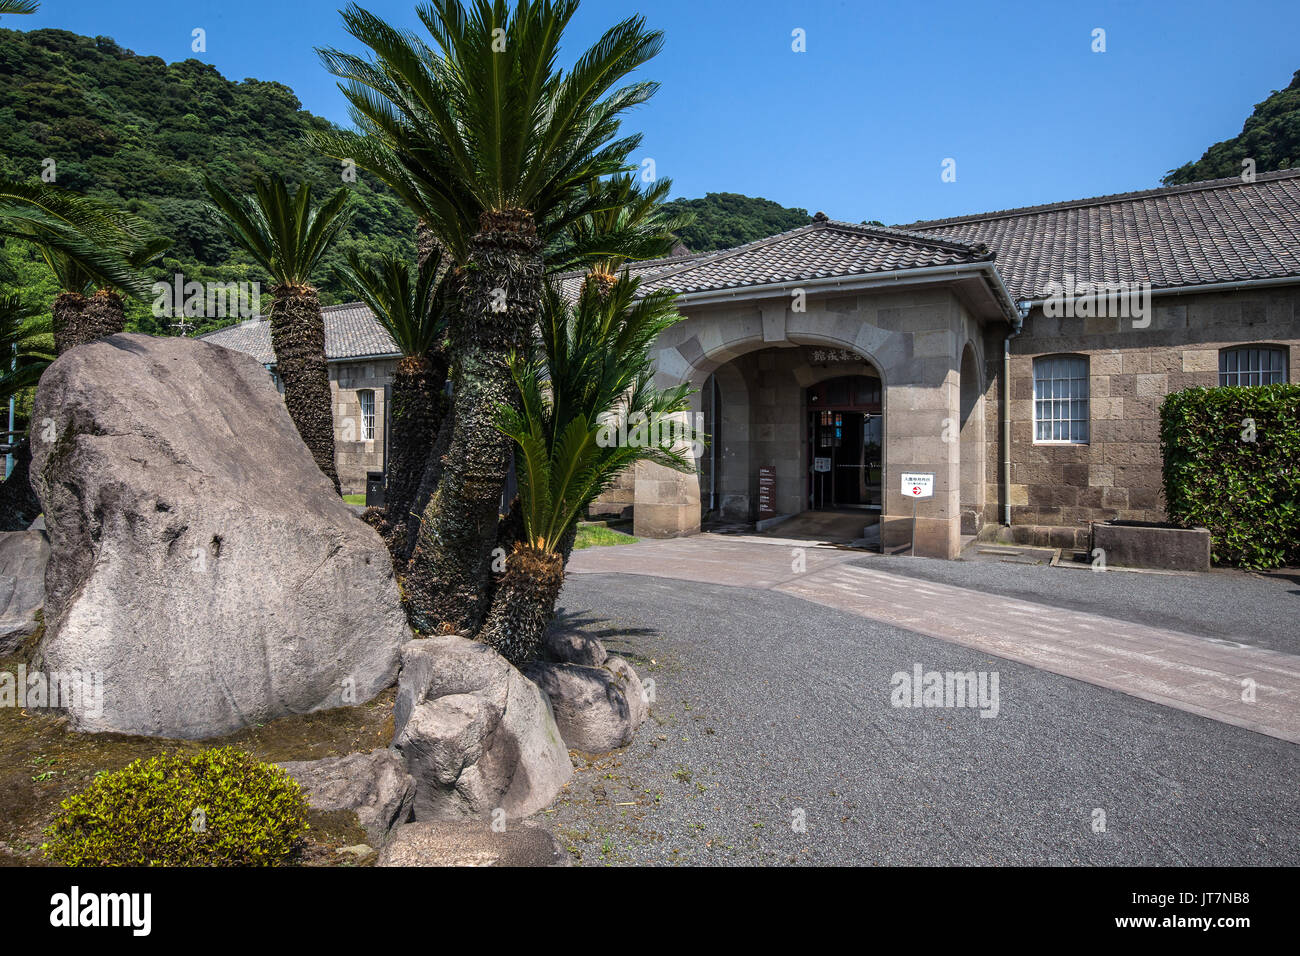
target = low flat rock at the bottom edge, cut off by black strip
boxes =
[374,819,572,866]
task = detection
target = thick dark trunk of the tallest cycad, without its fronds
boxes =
[406,209,542,632]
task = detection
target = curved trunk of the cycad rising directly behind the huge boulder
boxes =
[270,285,341,492]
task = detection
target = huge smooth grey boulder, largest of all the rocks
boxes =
[31,334,410,737]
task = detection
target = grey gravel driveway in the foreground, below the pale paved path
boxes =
[542,574,1300,865]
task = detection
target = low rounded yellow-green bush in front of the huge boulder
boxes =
[44,747,307,866]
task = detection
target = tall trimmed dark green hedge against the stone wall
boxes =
[1160,385,1300,570]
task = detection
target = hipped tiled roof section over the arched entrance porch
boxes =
[560,219,992,303]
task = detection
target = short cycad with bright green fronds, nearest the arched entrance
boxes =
[481,276,703,665]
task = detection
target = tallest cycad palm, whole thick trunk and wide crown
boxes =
[317,0,662,631]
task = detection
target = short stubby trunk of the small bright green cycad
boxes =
[480,546,564,667]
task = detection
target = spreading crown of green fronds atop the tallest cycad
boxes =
[317,0,663,254]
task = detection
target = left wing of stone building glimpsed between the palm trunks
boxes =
[203,302,400,494]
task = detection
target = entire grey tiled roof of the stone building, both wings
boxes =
[204,169,1300,364]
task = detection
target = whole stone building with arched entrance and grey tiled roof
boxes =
[208,170,1300,557]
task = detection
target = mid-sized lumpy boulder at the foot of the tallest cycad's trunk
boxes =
[394,635,573,821]
